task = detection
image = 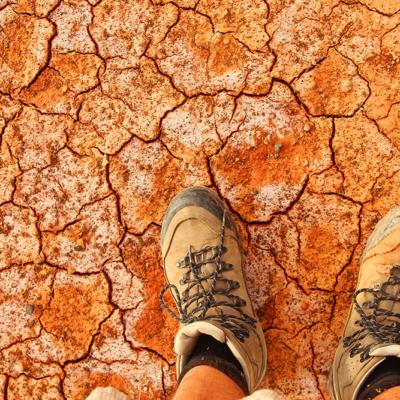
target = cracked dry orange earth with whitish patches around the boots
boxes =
[0,0,400,400]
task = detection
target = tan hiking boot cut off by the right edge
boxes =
[328,206,400,400]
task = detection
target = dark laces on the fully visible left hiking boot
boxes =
[160,210,256,342]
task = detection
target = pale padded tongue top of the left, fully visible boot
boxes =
[174,321,225,356]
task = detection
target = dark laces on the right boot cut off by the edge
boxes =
[343,265,400,362]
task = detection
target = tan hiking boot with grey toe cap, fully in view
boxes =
[160,186,267,393]
